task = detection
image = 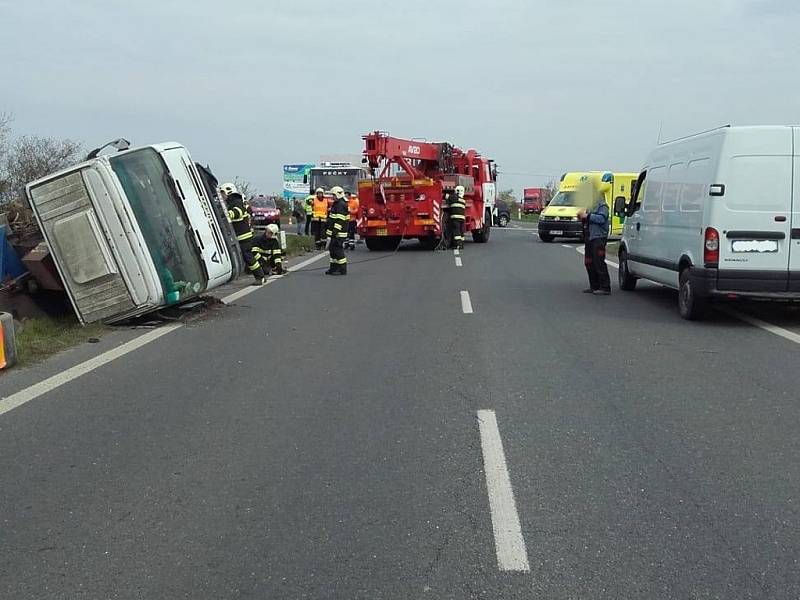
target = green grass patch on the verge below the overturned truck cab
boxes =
[16,316,106,367]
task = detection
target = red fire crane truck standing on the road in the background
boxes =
[358,131,497,250]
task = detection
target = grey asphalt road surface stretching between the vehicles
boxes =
[0,229,800,600]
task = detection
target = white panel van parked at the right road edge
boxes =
[614,126,800,319]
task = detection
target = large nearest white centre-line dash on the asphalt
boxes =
[478,410,531,571]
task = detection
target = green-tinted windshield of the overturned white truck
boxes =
[111,148,208,304]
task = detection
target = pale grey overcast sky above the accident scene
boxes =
[0,0,800,193]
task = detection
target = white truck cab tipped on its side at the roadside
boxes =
[26,143,241,323]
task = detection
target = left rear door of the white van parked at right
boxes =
[709,127,793,292]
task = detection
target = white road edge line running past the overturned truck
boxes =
[0,253,327,415]
